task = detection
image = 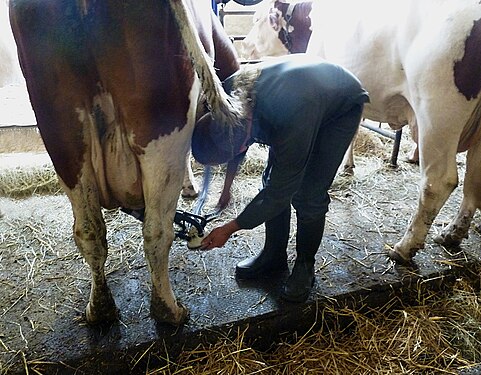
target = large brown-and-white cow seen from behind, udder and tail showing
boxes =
[10,0,242,325]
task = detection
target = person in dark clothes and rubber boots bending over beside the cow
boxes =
[192,54,369,302]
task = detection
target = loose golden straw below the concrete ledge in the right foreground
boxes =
[147,281,481,375]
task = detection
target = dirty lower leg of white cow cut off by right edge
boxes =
[434,143,481,247]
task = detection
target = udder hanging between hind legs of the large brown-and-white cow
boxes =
[101,126,144,209]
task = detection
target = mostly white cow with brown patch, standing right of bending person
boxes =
[307,0,481,263]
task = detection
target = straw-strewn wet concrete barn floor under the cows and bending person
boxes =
[0,145,481,374]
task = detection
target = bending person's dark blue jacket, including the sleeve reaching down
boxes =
[232,55,369,229]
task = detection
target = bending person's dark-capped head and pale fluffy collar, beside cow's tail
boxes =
[192,70,259,165]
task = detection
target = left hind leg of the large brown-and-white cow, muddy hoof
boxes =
[65,178,118,324]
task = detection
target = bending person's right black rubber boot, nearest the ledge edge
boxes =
[281,218,325,303]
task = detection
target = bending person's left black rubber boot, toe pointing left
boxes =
[236,207,291,279]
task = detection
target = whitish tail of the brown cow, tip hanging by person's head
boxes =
[169,0,244,125]
